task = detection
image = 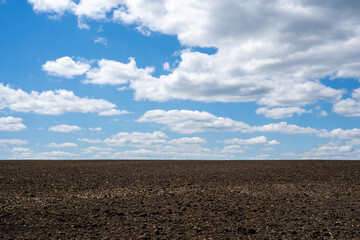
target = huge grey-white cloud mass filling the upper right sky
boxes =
[30,0,360,107]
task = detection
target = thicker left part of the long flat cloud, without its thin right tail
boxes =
[137,109,249,134]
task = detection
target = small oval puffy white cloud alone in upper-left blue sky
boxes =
[42,56,91,78]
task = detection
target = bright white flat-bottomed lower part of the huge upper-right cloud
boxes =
[130,52,343,106]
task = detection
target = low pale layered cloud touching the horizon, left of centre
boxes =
[79,131,217,159]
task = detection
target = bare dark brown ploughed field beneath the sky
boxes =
[0,161,360,239]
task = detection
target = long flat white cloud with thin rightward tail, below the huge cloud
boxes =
[137,109,318,134]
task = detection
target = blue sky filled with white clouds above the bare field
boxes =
[0,0,360,159]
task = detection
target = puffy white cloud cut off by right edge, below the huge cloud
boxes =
[333,88,360,117]
